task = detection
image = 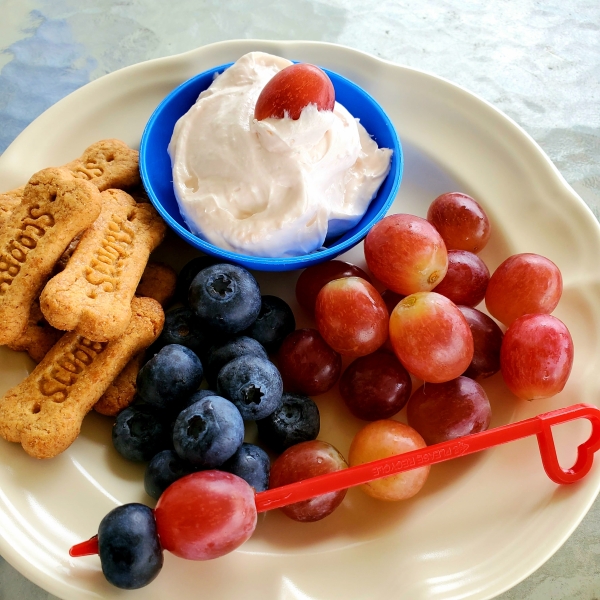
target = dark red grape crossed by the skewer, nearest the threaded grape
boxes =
[269,440,348,522]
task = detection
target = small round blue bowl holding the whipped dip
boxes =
[140,64,404,271]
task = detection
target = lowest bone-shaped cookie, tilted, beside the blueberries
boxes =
[0,298,164,458]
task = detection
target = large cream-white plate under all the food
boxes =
[0,40,600,600]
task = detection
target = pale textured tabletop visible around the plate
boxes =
[0,0,600,600]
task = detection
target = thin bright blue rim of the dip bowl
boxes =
[139,61,404,271]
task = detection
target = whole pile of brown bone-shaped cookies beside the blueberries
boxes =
[0,140,176,458]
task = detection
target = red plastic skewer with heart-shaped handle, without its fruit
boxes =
[69,404,600,557]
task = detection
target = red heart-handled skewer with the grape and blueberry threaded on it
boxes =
[69,404,600,589]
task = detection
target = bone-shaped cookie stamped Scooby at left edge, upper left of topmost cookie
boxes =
[0,168,102,345]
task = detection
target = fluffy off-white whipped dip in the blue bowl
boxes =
[169,52,392,257]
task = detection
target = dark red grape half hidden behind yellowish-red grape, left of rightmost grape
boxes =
[458,306,504,379]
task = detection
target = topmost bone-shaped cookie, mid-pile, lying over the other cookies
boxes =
[40,190,166,342]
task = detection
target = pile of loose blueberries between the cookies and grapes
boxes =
[112,257,320,499]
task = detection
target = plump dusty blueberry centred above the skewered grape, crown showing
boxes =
[173,396,244,469]
